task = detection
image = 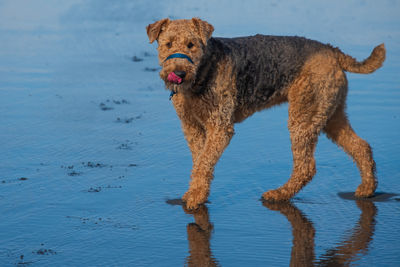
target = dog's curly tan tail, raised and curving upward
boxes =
[335,44,386,73]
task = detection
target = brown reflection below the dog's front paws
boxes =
[183,205,218,266]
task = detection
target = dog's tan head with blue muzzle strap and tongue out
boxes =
[146,18,214,92]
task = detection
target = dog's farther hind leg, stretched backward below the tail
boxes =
[324,105,378,197]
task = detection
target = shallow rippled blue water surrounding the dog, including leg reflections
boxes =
[0,0,400,266]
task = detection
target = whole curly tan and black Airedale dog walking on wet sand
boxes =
[146,18,386,209]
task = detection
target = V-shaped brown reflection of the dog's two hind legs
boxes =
[263,200,377,266]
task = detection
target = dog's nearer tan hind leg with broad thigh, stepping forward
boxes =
[263,59,346,201]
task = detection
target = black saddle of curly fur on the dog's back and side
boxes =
[194,35,331,107]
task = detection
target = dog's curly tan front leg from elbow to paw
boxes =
[182,121,234,209]
